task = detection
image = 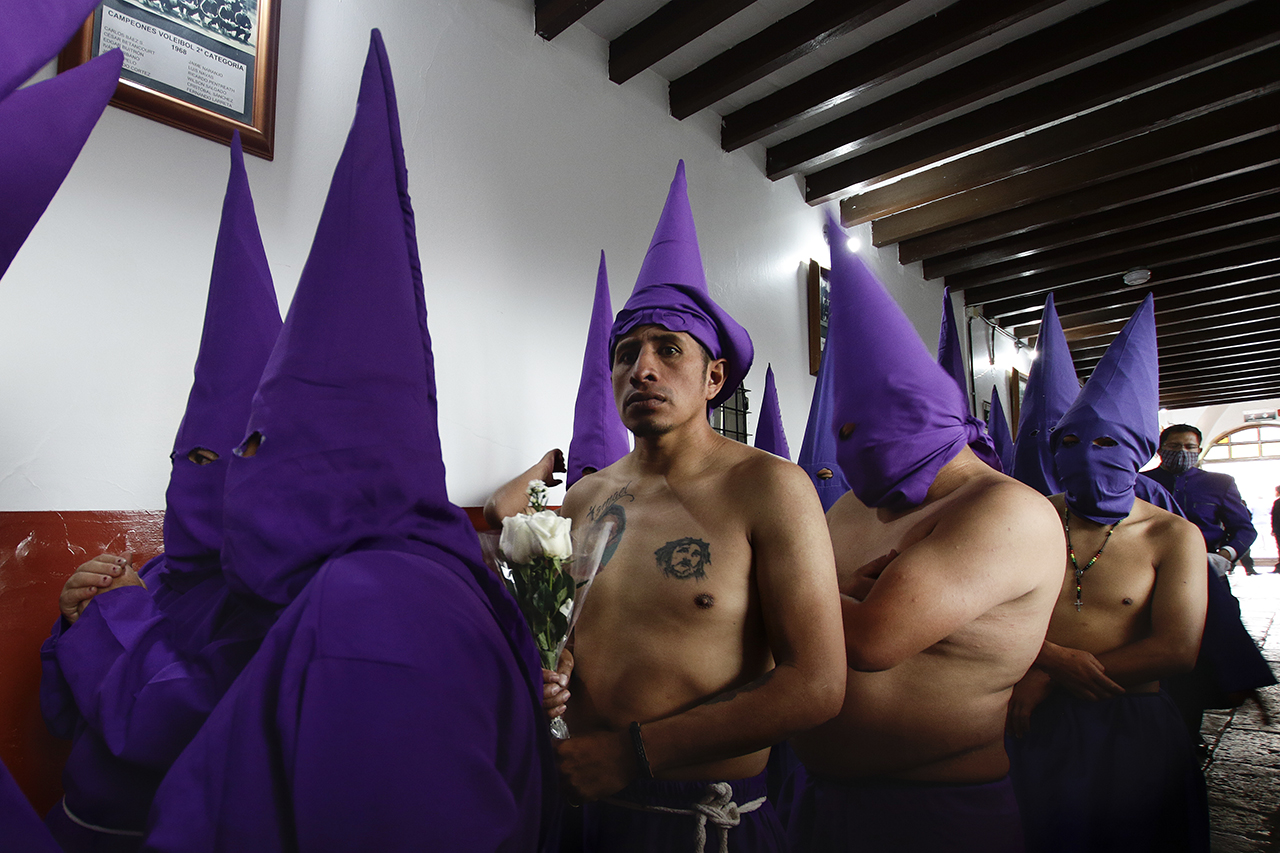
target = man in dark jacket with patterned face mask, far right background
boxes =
[1143,424,1258,575]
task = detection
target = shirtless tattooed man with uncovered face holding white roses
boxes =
[494,167,844,852]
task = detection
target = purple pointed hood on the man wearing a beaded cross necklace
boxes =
[1051,293,1160,524]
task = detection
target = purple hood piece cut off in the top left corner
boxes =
[0,0,101,99]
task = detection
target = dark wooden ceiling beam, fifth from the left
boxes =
[764,0,1219,181]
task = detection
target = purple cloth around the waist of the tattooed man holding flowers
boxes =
[582,774,787,853]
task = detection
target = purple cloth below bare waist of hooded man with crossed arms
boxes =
[787,776,1025,853]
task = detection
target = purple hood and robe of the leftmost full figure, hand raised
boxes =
[41,134,280,850]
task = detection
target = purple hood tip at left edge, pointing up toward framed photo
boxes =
[0,48,124,275]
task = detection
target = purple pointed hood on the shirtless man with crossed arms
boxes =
[827,211,1000,510]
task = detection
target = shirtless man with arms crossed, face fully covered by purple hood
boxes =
[791,220,1064,853]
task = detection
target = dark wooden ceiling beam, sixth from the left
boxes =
[803,0,1280,196]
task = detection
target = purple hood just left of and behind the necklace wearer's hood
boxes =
[1014,293,1080,494]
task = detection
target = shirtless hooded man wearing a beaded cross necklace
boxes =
[1009,296,1208,853]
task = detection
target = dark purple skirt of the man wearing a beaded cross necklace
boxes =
[1006,690,1208,853]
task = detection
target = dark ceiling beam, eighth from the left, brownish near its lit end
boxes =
[860,91,1280,246]
